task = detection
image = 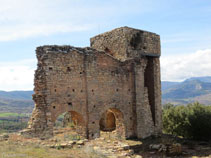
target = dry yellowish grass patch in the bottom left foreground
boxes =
[0,142,103,158]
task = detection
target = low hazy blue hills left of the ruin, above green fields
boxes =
[0,91,34,113]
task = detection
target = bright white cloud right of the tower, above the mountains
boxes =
[161,49,211,81]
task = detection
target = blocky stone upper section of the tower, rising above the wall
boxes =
[90,27,160,61]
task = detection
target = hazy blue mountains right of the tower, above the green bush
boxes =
[162,76,211,105]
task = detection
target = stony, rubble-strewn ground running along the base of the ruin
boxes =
[0,129,211,158]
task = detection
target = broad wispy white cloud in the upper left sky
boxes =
[0,0,93,41]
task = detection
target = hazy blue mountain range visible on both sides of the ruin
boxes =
[0,76,211,113]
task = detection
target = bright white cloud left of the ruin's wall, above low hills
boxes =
[0,60,36,91]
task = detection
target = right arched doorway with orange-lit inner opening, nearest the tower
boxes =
[99,108,125,138]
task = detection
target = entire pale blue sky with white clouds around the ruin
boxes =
[0,0,211,90]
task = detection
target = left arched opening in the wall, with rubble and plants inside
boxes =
[54,111,86,137]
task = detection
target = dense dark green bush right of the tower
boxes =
[163,103,211,140]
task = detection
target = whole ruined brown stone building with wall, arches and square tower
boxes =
[23,27,162,139]
